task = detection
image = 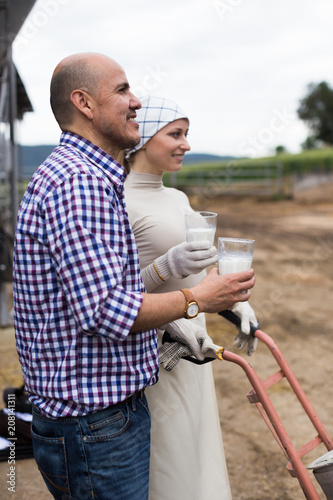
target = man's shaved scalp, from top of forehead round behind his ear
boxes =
[50,52,120,130]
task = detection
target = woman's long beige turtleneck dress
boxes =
[125,171,231,500]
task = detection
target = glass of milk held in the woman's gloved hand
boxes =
[185,212,217,246]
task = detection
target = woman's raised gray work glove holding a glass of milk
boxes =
[141,240,217,292]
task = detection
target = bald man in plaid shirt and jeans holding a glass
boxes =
[14,53,254,500]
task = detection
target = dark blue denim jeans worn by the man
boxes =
[31,393,150,500]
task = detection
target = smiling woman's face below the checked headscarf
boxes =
[144,118,191,174]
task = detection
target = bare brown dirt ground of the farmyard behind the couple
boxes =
[0,185,333,500]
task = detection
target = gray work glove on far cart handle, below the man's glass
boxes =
[231,302,259,356]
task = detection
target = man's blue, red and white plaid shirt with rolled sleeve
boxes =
[14,133,158,418]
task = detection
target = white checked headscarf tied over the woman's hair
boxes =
[126,95,189,158]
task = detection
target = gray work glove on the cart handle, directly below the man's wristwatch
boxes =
[159,319,223,371]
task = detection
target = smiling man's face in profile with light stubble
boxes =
[93,61,141,154]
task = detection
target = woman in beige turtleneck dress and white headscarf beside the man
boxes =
[125,96,231,500]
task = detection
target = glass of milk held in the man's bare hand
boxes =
[218,238,255,274]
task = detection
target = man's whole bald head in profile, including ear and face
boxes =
[47,52,141,158]
